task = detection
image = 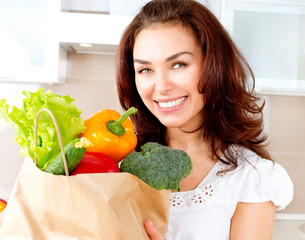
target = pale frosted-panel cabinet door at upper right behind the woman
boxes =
[224,0,305,95]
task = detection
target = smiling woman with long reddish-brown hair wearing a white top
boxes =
[116,0,293,240]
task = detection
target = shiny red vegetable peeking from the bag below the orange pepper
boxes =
[71,152,120,175]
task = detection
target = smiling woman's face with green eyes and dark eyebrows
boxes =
[133,25,204,130]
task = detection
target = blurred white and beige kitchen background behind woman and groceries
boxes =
[0,0,305,240]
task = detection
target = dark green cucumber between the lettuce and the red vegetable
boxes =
[44,138,86,175]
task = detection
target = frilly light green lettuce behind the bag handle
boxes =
[0,88,85,169]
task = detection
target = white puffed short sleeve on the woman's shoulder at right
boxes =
[225,145,293,210]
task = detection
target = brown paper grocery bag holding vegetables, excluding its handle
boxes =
[0,158,170,240]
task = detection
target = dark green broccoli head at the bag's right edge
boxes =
[120,142,193,191]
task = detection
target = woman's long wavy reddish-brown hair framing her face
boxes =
[115,0,271,169]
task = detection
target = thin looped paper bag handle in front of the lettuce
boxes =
[35,108,69,176]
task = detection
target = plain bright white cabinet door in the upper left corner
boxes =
[0,0,60,83]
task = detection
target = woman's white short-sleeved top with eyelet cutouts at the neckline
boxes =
[166,145,293,240]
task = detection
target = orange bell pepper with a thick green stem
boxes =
[80,107,137,163]
